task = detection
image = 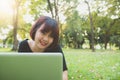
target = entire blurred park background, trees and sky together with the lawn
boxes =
[0,0,120,80]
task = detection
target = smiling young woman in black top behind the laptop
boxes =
[18,16,68,80]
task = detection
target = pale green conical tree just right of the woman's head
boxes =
[64,10,84,48]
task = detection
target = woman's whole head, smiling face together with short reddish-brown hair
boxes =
[30,16,59,51]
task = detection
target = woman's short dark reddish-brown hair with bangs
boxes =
[30,16,59,49]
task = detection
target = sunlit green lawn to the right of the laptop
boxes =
[63,49,120,80]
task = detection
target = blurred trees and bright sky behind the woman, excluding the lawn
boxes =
[0,0,120,51]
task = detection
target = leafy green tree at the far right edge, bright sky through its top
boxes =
[87,0,120,49]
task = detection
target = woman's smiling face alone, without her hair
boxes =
[34,24,54,50]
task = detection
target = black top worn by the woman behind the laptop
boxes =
[18,39,67,71]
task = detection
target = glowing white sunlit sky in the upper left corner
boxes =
[0,0,13,39]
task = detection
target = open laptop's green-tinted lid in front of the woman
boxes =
[0,53,63,80]
